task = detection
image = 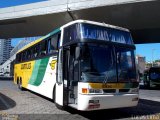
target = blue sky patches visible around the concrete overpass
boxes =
[0,0,160,62]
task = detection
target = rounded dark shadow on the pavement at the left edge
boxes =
[0,93,16,111]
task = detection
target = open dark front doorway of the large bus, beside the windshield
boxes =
[63,47,78,106]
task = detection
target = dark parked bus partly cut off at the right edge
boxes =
[143,66,160,88]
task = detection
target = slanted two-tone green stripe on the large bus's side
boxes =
[29,58,49,86]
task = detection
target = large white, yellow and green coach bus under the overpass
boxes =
[14,20,139,111]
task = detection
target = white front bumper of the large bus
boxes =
[78,94,139,111]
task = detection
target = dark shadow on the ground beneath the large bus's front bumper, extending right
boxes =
[67,99,160,120]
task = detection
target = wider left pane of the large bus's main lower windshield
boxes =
[81,44,117,82]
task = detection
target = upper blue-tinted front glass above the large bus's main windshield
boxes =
[81,23,133,44]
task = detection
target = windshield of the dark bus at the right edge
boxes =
[150,68,160,80]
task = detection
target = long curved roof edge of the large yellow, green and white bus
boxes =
[17,20,129,53]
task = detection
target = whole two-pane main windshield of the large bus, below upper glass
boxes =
[81,45,136,83]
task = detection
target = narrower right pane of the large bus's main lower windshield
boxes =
[116,48,136,82]
